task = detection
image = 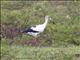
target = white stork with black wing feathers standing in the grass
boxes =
[22,16,51,45]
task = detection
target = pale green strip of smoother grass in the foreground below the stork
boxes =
[1,42,80,60]
